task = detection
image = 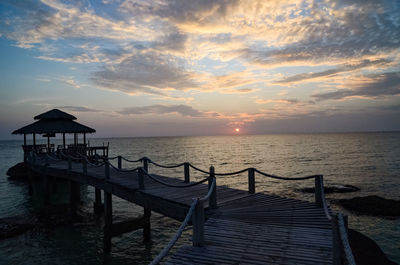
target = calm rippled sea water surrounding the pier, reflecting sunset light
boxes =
[0,133,400,264]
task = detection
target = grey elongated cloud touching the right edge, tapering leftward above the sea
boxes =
[312,72,400,101]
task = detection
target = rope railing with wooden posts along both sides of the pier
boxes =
[28,151,355,265]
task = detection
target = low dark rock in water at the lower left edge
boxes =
[0,213,36,240]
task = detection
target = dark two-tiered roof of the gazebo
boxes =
[12,109,96,134]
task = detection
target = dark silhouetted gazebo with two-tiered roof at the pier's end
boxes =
[12,109,96,153]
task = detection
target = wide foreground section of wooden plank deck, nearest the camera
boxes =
[166,193,332,265]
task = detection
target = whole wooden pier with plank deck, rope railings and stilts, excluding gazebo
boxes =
[28,153,354,264]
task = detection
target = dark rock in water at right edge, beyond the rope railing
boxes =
[334,195,400,217]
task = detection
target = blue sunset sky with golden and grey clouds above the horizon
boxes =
[0,0,400,139]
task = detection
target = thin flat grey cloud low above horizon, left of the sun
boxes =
[118,105,205,117]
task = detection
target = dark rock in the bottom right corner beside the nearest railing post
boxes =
[349,229,398,265]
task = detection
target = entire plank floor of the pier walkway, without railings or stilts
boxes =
[30,156,332,265]
